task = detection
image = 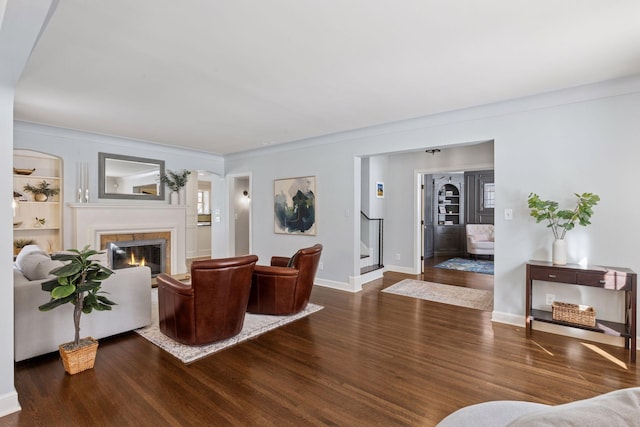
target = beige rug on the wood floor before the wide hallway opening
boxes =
[382,279,493,311]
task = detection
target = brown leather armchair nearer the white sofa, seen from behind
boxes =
[156,255,258,345]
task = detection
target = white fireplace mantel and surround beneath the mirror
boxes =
[68,203,187,274]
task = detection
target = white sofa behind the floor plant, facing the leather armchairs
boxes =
[13,247,151,362]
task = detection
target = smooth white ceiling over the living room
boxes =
[15,0,640,154]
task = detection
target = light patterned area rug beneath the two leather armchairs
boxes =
[135,289,324,363]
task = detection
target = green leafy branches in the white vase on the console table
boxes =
[527,193,600,239]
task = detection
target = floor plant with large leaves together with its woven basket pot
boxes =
[38,245,115,374]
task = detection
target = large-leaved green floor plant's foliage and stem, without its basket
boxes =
[38,245,116,347]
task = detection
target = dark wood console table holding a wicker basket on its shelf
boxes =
[525,261,638,363]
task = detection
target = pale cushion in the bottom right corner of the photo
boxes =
[508,387,640,427]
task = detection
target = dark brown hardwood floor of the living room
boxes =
[5,260,640,427]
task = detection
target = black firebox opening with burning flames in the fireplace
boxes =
[107,239,167,277]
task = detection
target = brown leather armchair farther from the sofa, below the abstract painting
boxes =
[247,244,322,315]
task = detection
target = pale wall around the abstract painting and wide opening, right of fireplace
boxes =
[226,76,640,342]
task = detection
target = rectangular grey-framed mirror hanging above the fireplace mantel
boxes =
[98,153,165,200]
